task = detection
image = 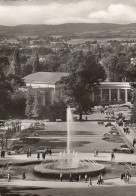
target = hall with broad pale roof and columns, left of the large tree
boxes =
[24,72,68,106]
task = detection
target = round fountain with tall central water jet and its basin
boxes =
[34,107,105,177]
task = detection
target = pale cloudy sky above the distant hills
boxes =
[0,0,136,25]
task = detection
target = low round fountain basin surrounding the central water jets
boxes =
[34,160,105,178]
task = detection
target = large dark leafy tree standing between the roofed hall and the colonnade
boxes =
[60,51,106,120]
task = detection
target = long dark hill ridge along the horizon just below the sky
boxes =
[0,23,136,34]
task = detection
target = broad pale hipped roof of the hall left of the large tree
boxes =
[24,72,68,85]
